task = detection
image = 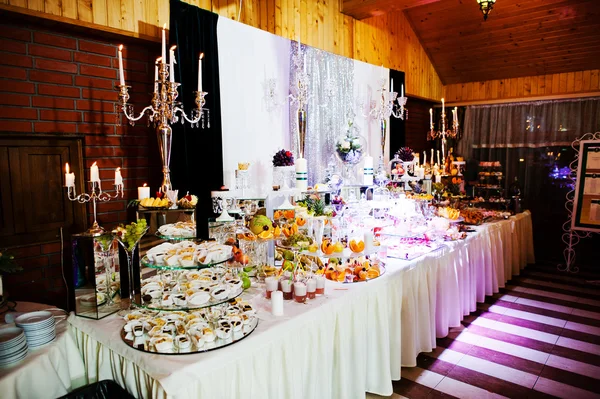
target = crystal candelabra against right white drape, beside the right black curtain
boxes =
[368,79,408,185]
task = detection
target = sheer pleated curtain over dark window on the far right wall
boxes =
[457,98,600,267]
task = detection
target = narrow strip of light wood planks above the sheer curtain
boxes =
[444,69,600,103]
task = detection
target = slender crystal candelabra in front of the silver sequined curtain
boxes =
[289,42,311,158]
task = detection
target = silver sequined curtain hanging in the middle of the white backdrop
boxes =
[290,42,356,186]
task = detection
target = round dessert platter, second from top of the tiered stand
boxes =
[142,241,233,270]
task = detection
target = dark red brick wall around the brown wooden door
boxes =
[0,18,160,307]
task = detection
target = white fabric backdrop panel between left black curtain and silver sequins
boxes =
[217,17,290,194]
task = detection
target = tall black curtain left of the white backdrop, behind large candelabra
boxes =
[167,0,223,239]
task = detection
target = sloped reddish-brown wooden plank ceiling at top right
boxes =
[344,0,600,84]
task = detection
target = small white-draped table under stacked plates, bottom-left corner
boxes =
[0,302,86,399]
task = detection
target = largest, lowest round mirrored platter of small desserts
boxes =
[121,298,258,355]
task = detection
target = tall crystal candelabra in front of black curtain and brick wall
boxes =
[117,60,210,193]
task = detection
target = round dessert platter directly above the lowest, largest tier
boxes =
[138,267,244,310]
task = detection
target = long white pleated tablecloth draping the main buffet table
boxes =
[69,211,534,399]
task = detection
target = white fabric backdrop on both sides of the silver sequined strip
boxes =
[217,17,392,190]
